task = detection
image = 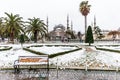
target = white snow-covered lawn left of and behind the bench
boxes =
[0,45,36,68]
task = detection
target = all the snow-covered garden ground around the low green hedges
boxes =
[0,43,120,69]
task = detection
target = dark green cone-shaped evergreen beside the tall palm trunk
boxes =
[85,26,94,46]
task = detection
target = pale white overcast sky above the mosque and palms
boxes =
[0,0,120,33]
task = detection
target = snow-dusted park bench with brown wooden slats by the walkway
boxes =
[14,55,49,72]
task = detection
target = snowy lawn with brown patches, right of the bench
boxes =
[50,47,120,69]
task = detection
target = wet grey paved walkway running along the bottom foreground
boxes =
[0,69,120,80]
